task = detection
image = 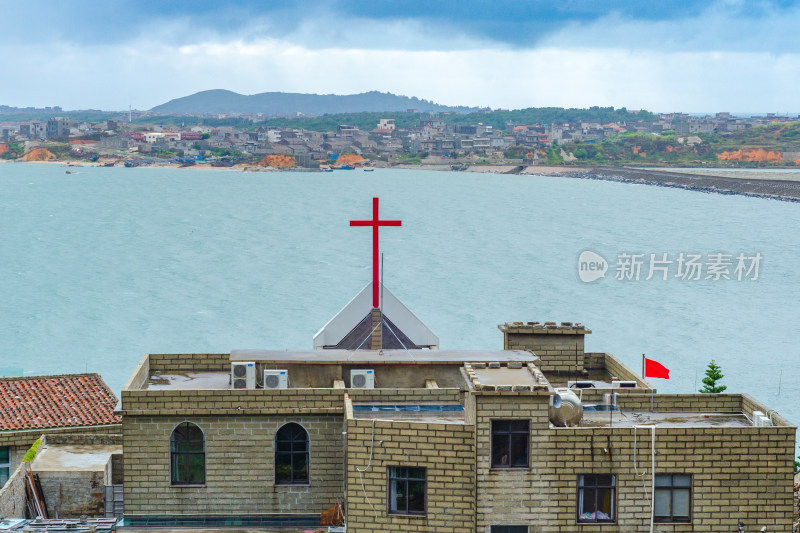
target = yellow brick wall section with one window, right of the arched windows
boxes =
[347,420,475,533]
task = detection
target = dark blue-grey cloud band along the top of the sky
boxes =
[0,0,798,51]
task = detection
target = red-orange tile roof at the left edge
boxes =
[0,374,121,431]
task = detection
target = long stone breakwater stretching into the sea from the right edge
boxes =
[558,167,800,202]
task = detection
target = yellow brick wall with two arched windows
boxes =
[123,415,344,516]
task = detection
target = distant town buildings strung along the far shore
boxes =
[0,112,797,167]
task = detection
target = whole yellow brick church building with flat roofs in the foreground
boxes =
[121,316,795,533]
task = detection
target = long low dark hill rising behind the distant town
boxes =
[151,89,475,115]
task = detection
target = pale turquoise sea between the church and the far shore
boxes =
[0,163,800,436]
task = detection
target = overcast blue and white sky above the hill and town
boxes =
[0,0,800,113]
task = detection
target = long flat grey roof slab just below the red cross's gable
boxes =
[231,350,538,364]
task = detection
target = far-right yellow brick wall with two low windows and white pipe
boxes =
[531,428,794,532]
